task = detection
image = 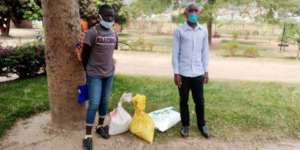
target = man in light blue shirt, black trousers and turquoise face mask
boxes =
[172,4,209,138]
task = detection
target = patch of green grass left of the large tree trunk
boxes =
[0,77,49,137]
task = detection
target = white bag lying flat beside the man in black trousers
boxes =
[149,107,181,132]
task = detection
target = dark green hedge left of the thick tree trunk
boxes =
[0,43,46,78]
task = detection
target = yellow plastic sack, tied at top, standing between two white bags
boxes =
[129,95,154,143]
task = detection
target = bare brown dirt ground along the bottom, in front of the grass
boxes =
[0,112,300,150]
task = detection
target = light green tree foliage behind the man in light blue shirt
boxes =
[173,0,300,45]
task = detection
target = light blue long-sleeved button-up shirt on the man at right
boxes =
[172,23,209,77]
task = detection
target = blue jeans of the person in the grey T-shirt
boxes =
[86,76,113,126]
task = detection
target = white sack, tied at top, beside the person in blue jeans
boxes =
[109,93,132,135]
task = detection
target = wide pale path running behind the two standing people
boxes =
[114,51,300,83]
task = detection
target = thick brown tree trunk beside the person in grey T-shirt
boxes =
[42,0,85,129]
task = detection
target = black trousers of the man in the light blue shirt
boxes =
[178,76,205,127]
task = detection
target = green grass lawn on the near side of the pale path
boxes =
[0,75,300,141]
